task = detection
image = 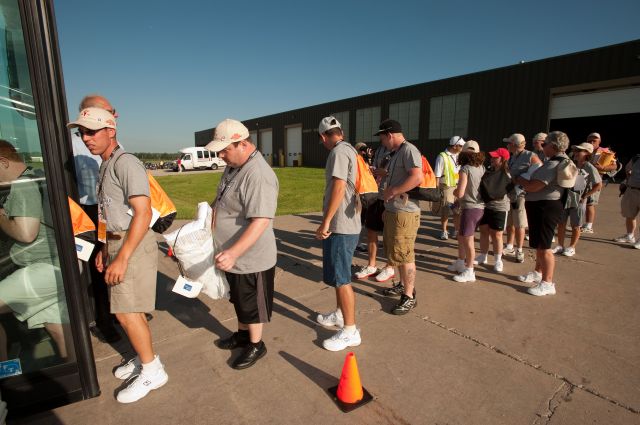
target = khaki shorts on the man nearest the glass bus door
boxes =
[107,230,158,314]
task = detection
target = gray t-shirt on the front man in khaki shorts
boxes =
[98,148,151,232]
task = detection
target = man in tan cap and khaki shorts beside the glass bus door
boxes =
[67,108,169,403]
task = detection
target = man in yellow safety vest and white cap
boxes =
[433,136,465,241]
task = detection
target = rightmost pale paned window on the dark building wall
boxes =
[429,93,471,139]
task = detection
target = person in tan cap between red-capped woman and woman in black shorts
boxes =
[502,133,542,263]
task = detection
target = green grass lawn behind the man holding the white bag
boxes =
[156,167,324,219]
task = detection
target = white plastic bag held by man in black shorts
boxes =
[163,202,229,300]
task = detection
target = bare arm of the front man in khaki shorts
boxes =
[104,195,152,285]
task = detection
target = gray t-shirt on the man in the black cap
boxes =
[380,141,422,213]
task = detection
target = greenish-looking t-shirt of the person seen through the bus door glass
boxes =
[4,172,58,267]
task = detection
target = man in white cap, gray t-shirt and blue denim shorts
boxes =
[316,117,362,351]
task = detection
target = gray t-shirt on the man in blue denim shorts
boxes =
[322,142,362,235]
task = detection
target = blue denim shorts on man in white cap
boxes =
[322,233,360,288]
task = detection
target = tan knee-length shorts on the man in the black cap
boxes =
[382,211,420,266]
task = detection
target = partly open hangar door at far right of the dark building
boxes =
[549,87,640,162]
